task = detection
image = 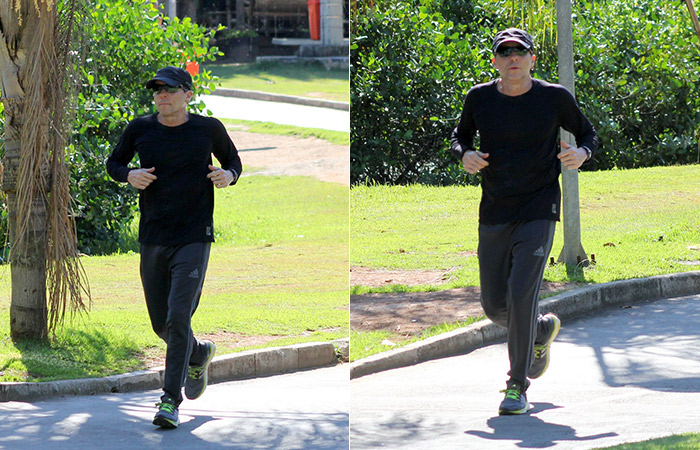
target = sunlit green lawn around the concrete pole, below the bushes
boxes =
[350,165,700,360]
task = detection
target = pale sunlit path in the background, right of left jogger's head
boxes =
[199,95,350,132]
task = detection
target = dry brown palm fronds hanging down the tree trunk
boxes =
[4,0,90,331]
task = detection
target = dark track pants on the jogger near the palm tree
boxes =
[141,242,211,404]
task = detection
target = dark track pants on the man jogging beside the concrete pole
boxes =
[478,220,555,386]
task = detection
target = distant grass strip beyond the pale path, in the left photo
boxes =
[202,62,350,102]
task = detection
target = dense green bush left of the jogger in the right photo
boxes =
[350,0,492,184]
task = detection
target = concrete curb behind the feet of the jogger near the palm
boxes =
[0,338,349,402]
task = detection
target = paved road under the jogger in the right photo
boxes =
[350,295,700,450]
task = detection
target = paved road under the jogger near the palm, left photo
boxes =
[0,365,349,450]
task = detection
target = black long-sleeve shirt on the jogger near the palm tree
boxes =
[107,114,242,245]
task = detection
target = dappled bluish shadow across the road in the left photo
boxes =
[0,393,348,450]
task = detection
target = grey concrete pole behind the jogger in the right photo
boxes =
[557,0,588,266]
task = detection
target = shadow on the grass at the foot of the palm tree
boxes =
[0,328,145,381]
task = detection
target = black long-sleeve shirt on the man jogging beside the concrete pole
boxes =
[451,79,598,224]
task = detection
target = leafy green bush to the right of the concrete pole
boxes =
[574,0,700,169]
